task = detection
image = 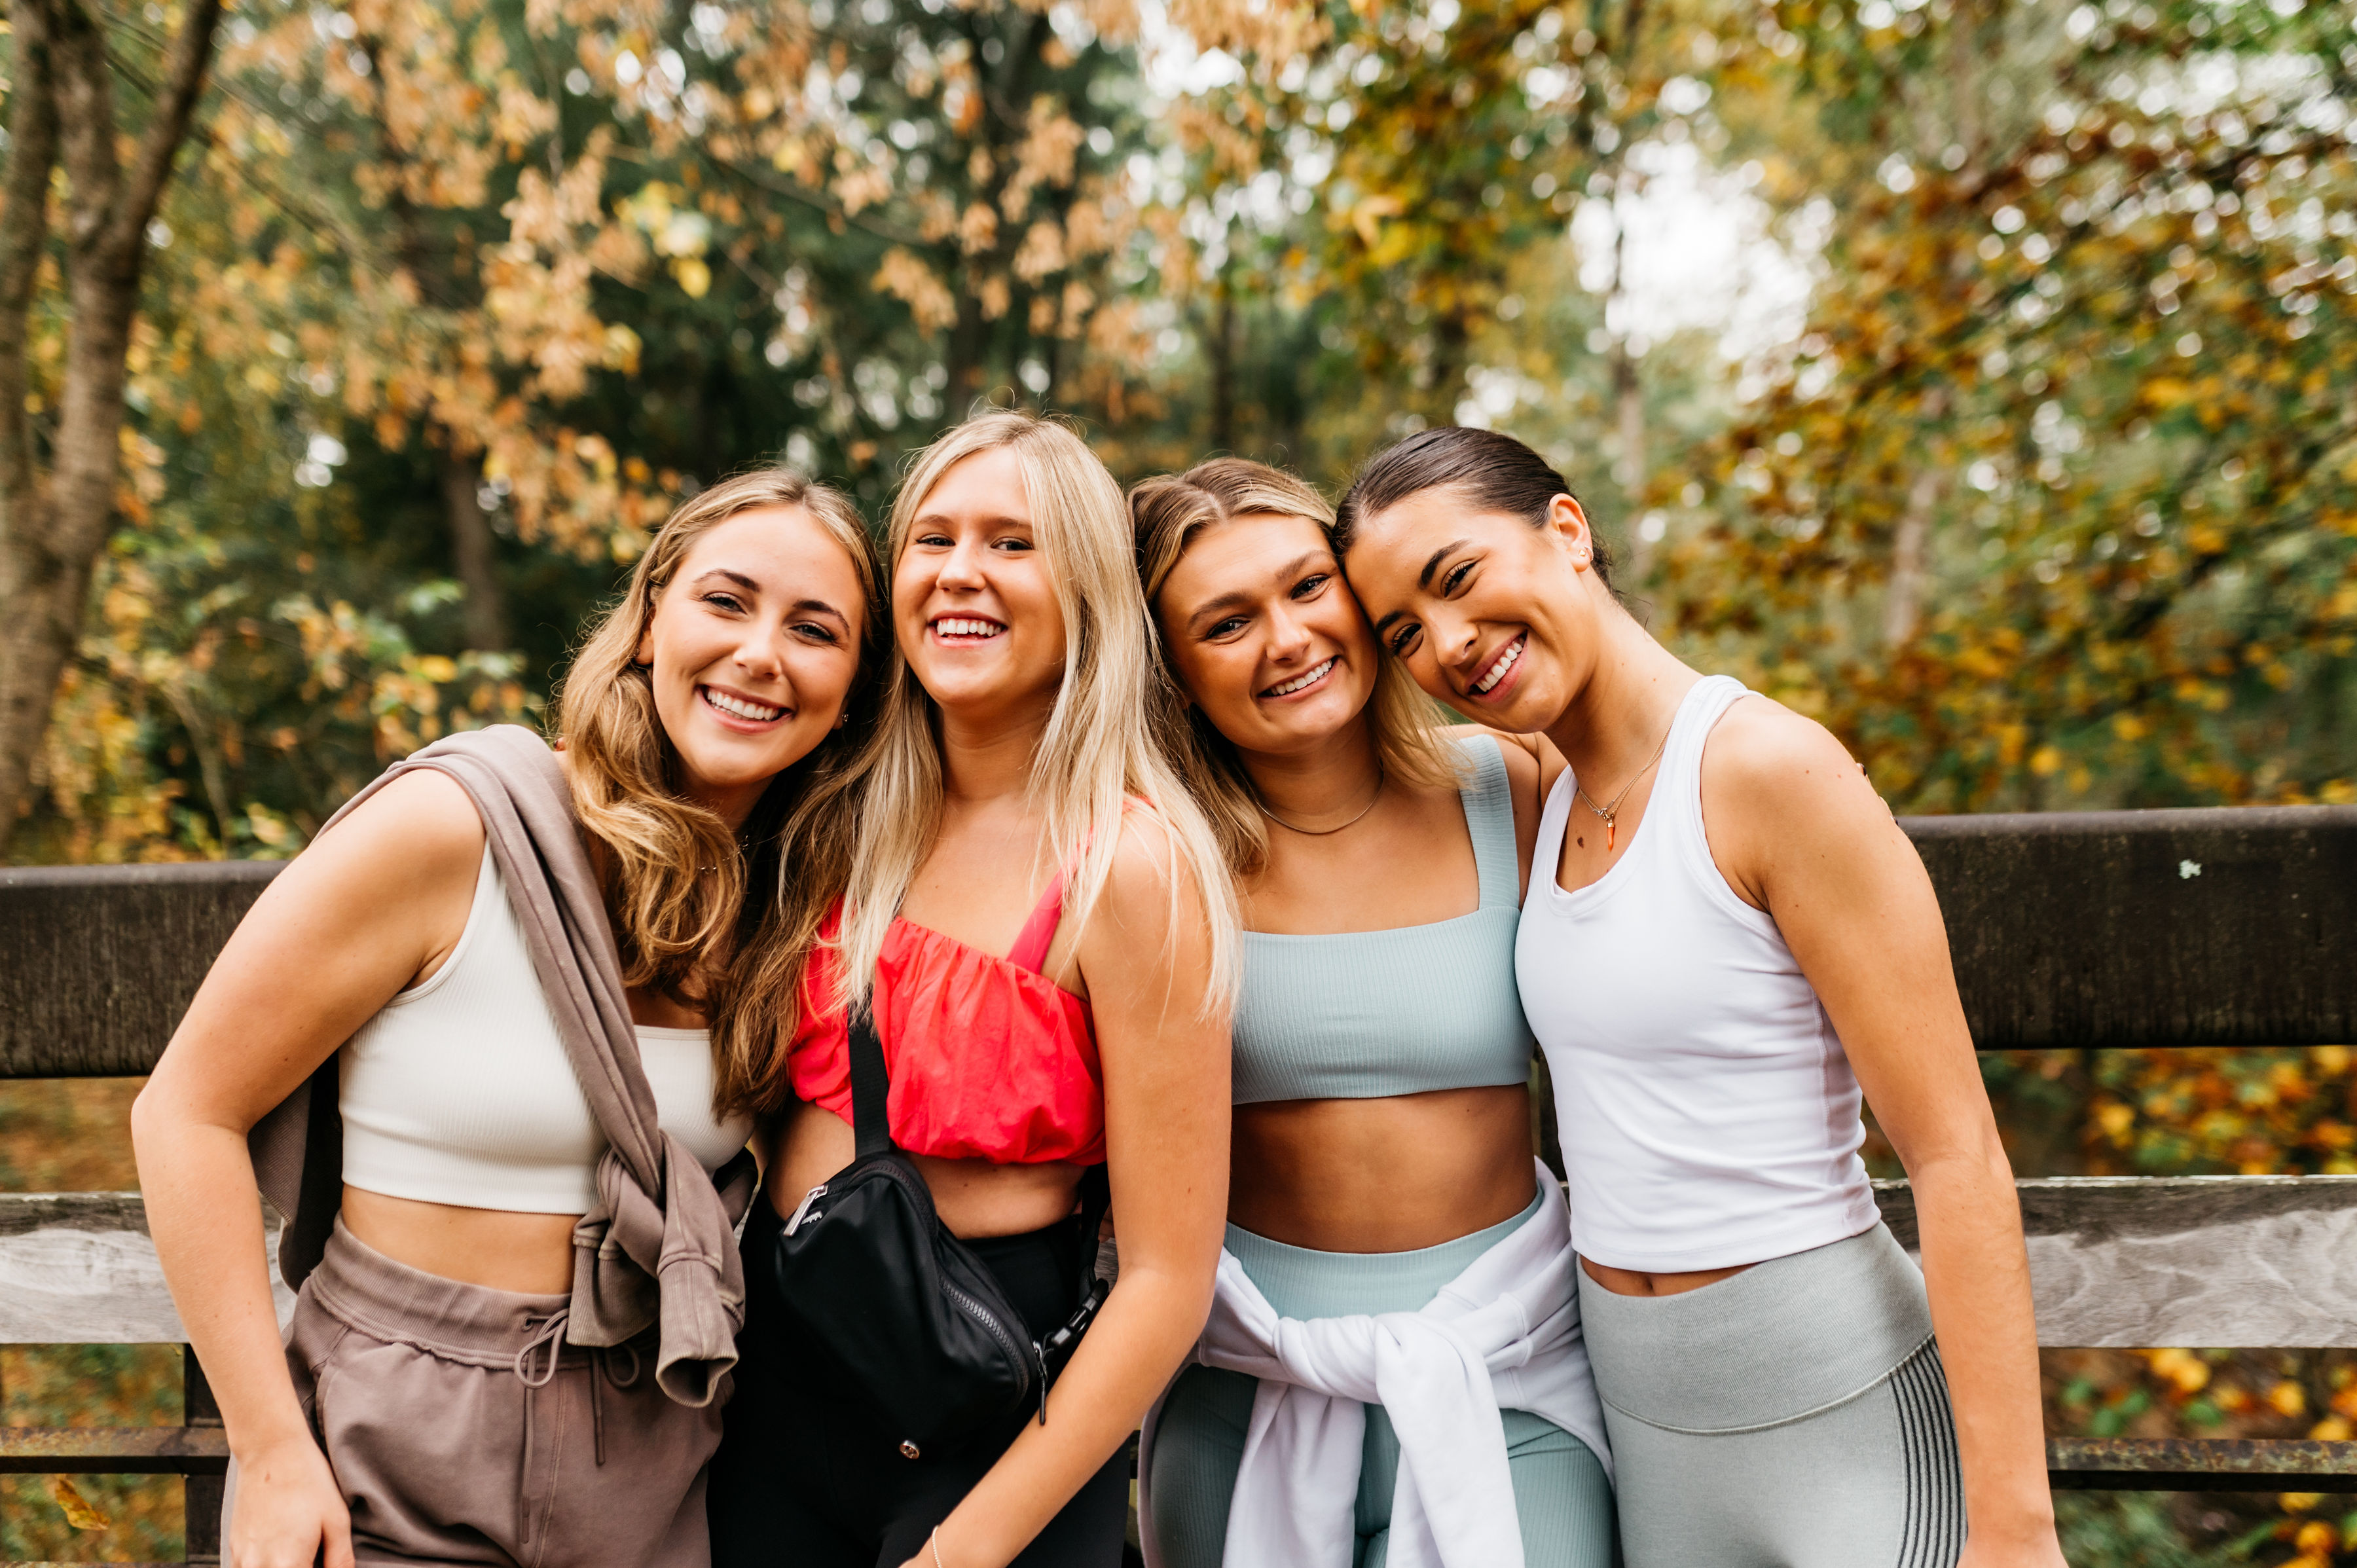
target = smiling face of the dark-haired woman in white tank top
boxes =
[1346,488,1610,733]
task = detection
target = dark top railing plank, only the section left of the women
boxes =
[0,861,280,1078]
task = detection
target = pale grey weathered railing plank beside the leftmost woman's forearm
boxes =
[0,1193,295,1344]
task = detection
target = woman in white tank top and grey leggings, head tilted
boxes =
[1339,429,2062,1568]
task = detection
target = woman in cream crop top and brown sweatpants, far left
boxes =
[132,469,881,1568]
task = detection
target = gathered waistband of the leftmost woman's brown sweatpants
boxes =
[304,1219,573,1368]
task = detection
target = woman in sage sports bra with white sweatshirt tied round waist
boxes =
[1131,460,1612,1568]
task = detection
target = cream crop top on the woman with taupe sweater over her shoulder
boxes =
[337,849,752,1214]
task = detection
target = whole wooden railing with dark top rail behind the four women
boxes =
[0,807,2357,1563]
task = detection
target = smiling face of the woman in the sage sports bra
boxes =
[1155,512,1376,754]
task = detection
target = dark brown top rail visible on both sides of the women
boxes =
[0,807,2357,1078]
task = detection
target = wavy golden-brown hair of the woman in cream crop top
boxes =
[557,467,886,1113]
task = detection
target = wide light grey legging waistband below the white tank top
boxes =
[1575,1224,1930,1431]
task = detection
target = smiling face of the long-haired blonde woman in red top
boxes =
[891,446,1065,717]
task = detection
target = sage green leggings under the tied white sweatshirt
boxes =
[1141,1212,1619,1568]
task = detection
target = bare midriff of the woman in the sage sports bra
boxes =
[1228,1085,1537,1252]
